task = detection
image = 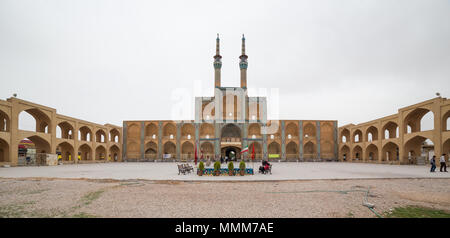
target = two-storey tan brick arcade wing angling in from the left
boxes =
[0,97,122,166]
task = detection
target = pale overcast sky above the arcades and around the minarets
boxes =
[0,0,450,130]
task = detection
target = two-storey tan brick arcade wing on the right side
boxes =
[338,97,450,164]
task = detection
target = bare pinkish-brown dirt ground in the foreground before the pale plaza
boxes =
[0,178,450,218]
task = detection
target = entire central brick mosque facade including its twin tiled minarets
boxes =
[123,38,338,161]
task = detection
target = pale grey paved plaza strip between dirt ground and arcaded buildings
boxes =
[0,162,450,181]
